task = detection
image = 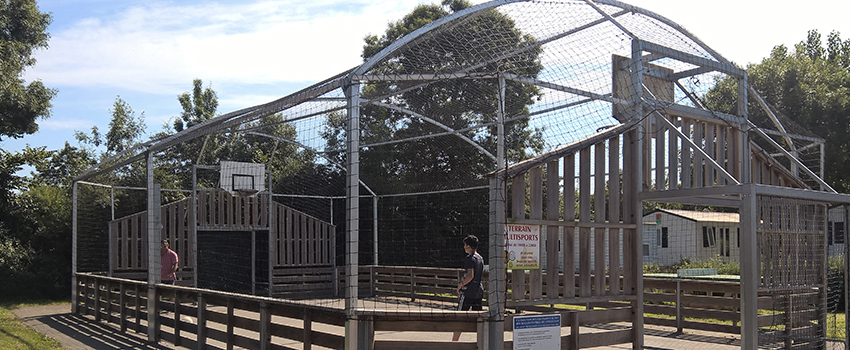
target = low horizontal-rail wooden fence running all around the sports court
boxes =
[76,266,817,350]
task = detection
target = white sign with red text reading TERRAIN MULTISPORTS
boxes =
[505,224,540,270]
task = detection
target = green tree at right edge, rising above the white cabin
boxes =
[705,30,850,193]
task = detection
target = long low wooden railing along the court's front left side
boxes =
[75,274,345,349]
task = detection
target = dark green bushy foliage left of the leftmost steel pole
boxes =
[0,143,94,299]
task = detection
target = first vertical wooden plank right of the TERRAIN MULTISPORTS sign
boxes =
[546,160,561,298]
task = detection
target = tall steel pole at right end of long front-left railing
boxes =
[344,81,360,350]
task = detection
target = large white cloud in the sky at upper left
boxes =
[28,0,428,94]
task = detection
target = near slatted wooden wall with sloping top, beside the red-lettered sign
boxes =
[508,129,639,307]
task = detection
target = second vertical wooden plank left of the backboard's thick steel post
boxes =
[608,133,620,295]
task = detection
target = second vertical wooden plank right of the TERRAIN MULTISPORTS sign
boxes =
[561,154,576,298]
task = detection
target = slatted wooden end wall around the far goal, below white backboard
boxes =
[109,190,336,290]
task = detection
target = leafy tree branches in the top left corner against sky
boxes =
[0,0,56,141]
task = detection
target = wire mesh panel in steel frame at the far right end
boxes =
[757,196,828,349]
